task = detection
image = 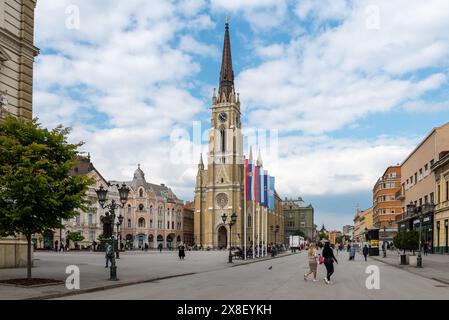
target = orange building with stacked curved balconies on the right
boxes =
[373,165,402,241]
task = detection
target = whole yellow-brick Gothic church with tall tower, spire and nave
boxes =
[194,21,284,253]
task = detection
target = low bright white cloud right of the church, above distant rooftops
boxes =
[264,136,417,197]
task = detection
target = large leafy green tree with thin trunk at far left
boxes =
[0,117,92,279]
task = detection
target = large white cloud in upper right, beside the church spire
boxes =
[237,0,449,133]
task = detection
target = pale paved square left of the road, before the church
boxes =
[0,251,290,299]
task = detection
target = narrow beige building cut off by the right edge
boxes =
[431,152,449,253]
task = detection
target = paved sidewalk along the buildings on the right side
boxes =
[368,251,449,284]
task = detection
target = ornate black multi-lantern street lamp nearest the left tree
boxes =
[95,183,129,280]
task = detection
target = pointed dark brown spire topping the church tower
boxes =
[218,17,234,99]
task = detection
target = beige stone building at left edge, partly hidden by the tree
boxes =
[0,0,39,268]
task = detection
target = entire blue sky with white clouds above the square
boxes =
[34,0,449,229]
